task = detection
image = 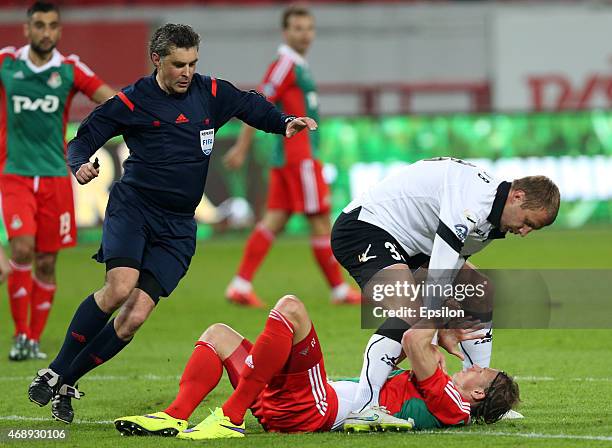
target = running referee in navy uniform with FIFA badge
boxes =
[28,24,317,423]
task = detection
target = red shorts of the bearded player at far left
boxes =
[0,174,76,252]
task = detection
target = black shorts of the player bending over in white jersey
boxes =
[331,207,429,289]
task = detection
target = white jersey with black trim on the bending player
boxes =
[344,157,511,270]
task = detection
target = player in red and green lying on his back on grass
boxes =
[115,295,519,439]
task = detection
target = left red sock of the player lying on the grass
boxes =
[164,341,223,420]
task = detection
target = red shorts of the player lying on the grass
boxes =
[225,326,338,432]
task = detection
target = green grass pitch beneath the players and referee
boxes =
[0,227,612,448]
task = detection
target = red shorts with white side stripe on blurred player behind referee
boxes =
[268,159,330,215]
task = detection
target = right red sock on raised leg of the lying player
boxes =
[223,309,293,425]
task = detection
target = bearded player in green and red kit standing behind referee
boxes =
[0,2,115,361]
